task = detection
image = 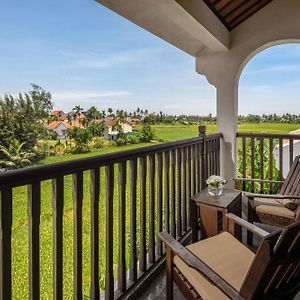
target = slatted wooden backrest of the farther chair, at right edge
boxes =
[280,155,300,196]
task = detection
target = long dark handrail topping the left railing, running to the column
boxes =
[0,133,222,189]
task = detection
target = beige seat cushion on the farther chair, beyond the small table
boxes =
[254,198,295,220]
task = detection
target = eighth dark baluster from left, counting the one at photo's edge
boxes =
[129,159,137,281]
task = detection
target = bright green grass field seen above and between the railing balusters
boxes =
[12,124,300,299]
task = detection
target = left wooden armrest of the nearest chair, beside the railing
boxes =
[158,231,242,300]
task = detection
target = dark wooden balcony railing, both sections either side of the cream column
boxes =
[0,127,299,299]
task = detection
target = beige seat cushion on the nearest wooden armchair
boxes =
[174,232,254,300]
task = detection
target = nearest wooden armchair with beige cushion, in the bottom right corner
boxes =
[159,214,300,300]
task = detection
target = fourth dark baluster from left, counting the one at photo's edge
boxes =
[72,172,83,299]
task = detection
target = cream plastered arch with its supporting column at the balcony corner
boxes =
[196,0,300,180]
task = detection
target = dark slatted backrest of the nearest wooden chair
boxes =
[240,222,300,299]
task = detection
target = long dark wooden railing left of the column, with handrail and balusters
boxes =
[0,128,221,300]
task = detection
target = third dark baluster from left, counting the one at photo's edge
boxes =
[52,176,64,300]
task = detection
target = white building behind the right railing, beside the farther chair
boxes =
[273,129,300,178]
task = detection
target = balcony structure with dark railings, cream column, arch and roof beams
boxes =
[0,0,300,300]
